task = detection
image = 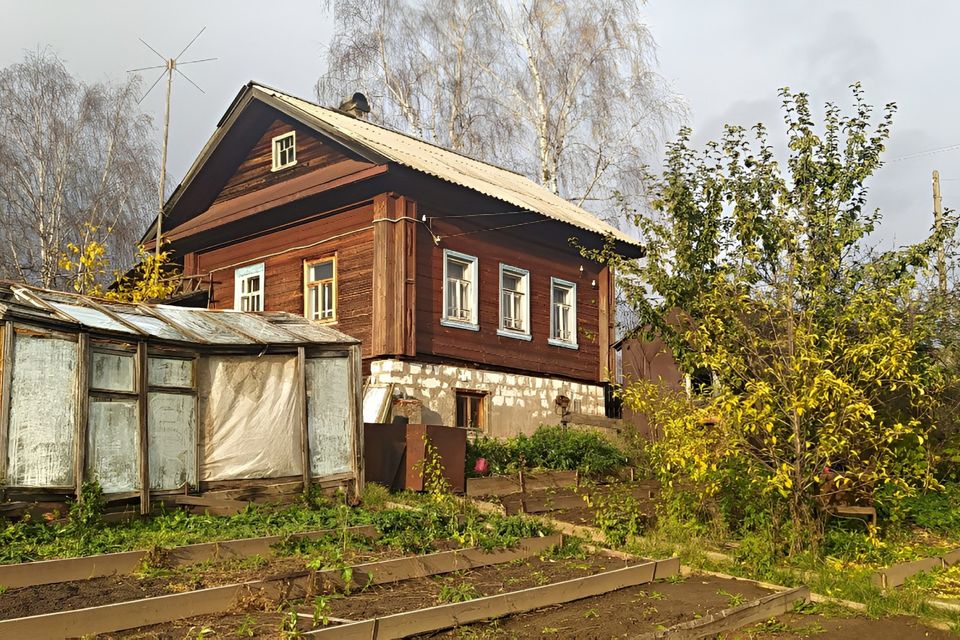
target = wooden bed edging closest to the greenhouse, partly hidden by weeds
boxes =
[0,525,377,589]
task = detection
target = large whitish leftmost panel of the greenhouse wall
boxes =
[7,333,77,487]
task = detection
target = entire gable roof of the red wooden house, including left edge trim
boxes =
[154,82,640,248]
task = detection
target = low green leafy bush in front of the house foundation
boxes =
[467,426,627,476]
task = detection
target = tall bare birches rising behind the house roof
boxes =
[317,0,685,224]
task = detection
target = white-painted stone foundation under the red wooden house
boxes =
[370,360,604,438]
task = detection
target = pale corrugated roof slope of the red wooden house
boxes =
[250,83,640,247]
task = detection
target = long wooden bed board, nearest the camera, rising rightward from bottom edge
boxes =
[304,558,680,640]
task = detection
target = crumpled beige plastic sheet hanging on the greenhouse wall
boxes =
[198,356,303,480]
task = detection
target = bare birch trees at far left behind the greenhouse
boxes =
[0,50,157,288]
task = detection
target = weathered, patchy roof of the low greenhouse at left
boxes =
[0,282,359,347]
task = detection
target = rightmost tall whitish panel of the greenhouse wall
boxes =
[306,358,354,478]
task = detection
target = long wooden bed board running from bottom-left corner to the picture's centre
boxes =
[0,535,564,640]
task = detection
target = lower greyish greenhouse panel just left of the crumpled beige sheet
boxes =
[147,390,197,490]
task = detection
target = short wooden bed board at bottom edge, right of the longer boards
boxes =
[633,587,810,640]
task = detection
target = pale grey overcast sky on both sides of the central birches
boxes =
[0,0,960,246]
